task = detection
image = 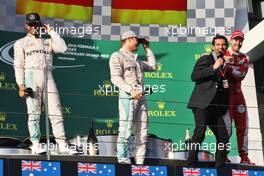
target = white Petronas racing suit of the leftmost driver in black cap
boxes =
[14,30,67,144]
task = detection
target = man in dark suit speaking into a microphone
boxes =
[187,34,229,167]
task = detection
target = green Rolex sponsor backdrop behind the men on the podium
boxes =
[0,31,239,155]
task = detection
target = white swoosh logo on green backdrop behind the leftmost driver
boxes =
[0,41,85,69]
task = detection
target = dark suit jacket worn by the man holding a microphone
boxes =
[188,54,228,110]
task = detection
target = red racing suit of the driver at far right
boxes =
[224,48,249,157]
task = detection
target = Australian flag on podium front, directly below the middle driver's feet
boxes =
[131,165,167,176]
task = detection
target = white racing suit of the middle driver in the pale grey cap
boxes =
[109,49,157,164]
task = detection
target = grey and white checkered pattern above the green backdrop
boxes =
[0,0,236,42]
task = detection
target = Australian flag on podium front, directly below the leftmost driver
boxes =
[21,160,61,176]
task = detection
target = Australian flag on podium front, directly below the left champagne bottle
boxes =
[78,163,115,176]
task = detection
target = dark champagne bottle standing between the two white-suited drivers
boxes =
[87,121,99,155]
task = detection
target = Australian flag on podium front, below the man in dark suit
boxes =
[182,167,217,176]
